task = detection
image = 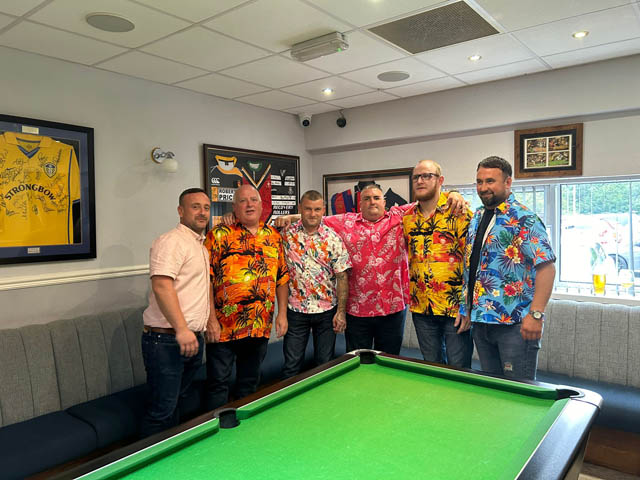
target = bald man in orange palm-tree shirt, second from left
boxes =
[205,185,289,410]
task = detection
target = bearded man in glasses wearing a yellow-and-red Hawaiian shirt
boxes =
[402,160,473,368]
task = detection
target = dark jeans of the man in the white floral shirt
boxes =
[282,307,337,378]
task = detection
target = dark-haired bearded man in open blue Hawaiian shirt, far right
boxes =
[459,157,556,380]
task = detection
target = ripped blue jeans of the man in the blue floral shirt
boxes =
[473,322,540,380]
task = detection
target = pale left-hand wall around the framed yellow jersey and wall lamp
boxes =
[0,47,311,328]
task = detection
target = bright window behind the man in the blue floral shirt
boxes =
[457,178,640,295]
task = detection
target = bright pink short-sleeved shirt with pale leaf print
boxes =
[324,204,414,317]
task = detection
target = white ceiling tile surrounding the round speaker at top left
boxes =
[29,0,189,47]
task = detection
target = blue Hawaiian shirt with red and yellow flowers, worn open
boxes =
[460,193,556,324]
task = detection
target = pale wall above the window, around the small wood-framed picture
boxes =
[305,56,640,188]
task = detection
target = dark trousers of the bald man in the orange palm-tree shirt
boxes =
[206,337,269,410]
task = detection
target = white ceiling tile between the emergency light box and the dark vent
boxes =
[305,32,405,73]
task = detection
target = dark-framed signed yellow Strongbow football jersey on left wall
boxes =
[0,114,96,264]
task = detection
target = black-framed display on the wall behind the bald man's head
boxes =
[203,144,300,226]
